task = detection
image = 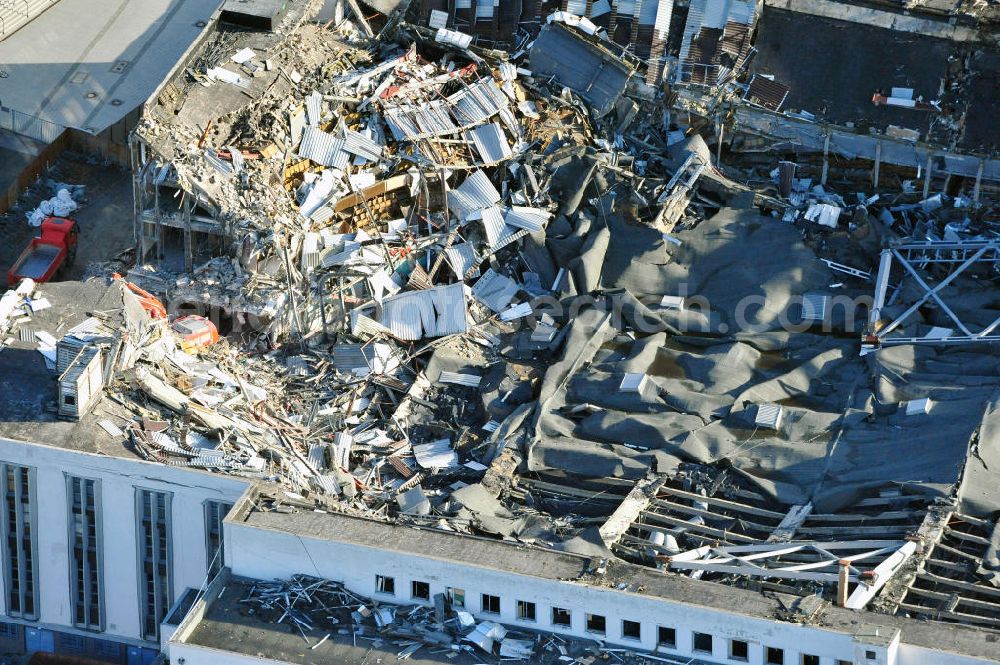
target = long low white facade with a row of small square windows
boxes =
[168,496,997,665]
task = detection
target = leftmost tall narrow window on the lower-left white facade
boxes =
[2,464,38,619]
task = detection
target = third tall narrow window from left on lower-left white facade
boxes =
[135,489,174,641]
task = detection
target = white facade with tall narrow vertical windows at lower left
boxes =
[0,438,247,663]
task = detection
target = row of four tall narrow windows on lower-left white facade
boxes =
[0,464,232,640]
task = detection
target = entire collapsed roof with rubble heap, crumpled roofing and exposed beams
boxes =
[0,2,1000,656]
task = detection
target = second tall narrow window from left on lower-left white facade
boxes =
[66,476,104,630]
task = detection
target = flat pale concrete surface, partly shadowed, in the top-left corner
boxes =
[0,0,221,133]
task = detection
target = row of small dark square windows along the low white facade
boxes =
[375,575,876,665]
